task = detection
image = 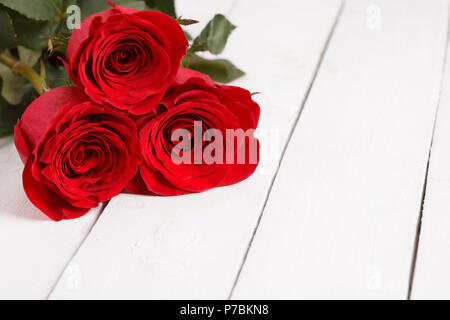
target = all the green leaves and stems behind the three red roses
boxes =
[0,0,244,135]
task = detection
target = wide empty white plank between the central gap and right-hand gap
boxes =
[232,0,449,299]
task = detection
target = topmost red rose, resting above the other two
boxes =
[66,2,188,114]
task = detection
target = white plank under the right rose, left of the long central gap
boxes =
[51,0,340,299]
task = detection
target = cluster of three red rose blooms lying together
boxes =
[7,4,260,220]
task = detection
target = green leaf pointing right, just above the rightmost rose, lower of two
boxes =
[186,54,245,83]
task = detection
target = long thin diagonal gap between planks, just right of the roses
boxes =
[228,0,346,300]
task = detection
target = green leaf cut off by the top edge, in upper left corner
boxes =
[0,0,62,21]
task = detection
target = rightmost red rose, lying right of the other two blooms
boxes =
[127,69,260,196]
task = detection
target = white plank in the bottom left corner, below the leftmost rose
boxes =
[0,137,99,299]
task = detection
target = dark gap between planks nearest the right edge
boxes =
[407,2,450,300]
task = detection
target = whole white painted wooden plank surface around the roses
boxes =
[0,0,450,299]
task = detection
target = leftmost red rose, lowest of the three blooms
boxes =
[14,87,142,221]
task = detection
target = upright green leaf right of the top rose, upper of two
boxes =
[192,14,236,54]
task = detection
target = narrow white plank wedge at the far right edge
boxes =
[411,26,450,299]
